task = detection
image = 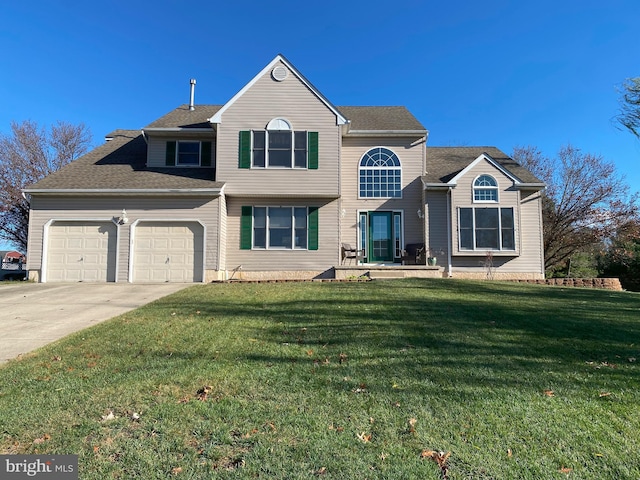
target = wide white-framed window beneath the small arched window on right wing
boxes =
[458,207,516,251]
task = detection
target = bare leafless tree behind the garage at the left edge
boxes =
[0,120,91,252]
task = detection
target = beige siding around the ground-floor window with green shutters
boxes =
[226,198,339,271]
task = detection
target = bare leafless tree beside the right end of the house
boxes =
[512,145,639,268]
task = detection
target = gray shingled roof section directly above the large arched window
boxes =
[336,107,426,131]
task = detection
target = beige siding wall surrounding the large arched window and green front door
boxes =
[340,137,424,244]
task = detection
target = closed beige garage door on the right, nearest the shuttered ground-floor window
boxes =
[133,222,204,283]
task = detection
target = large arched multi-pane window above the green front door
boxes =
[359,147,402,198]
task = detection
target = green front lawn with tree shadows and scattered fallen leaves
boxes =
[0,279,640,480]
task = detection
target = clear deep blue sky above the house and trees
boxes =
[0,0,640,248]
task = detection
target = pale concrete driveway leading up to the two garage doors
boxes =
[0,282,192,363]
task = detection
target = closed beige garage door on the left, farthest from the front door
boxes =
[46,222,117,282]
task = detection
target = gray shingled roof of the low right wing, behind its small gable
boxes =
[422,147,543,183]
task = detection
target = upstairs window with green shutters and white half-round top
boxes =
[239,118,318,169]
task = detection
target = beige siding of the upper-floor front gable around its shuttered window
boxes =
[216,64,340,197]
